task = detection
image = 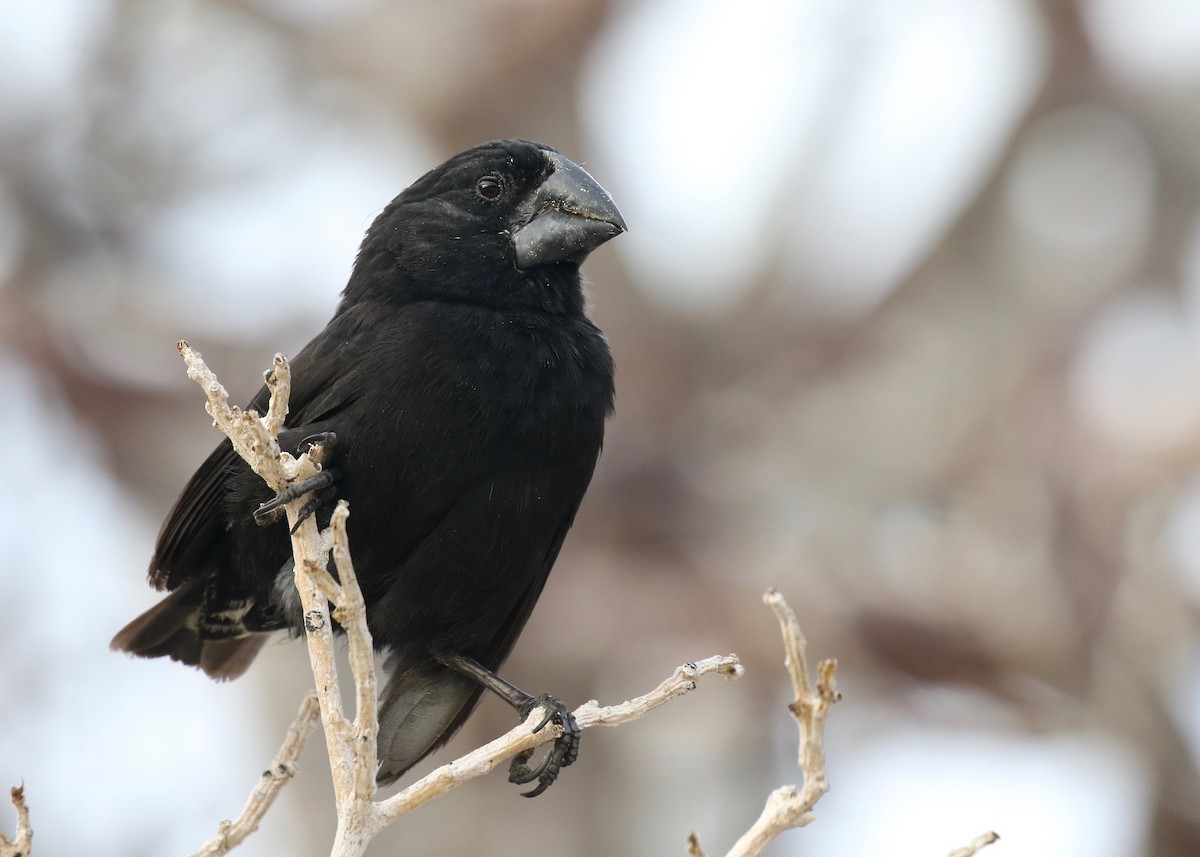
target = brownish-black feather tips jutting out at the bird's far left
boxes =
[109,577,268,679]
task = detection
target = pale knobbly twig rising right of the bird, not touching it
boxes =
[688,588,841,857]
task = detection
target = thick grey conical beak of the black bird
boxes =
[512,151,625,270]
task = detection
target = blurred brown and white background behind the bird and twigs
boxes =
[0,0,1200,857]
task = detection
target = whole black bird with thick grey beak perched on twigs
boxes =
[113,140,625,795]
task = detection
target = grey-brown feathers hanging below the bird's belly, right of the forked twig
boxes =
[376,664,482,785]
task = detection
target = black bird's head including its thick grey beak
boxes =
[343,140,625,312]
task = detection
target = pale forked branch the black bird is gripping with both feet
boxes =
[179,342,742,857]
